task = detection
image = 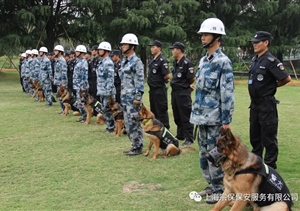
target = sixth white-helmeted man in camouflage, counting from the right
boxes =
[39,47,53,107]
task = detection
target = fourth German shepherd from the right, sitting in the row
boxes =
[80,89,105,125]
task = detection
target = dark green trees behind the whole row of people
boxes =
[0,0,300,67]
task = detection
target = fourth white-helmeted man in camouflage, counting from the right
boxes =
[73,45,89,123]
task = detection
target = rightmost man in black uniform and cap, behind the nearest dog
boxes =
[248,31,291,169]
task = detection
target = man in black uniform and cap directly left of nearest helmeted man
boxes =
[169,42,195,145]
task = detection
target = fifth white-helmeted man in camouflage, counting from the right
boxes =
[53,45,68,114]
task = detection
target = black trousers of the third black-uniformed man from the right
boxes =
[149,86,170,129]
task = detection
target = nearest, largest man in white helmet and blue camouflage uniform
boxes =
[190,18,234,204]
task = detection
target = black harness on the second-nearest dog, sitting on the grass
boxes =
[145,119,179,149]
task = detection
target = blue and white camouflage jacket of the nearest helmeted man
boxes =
[190,49,234,125]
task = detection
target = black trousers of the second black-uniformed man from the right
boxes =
[171,89,194,142]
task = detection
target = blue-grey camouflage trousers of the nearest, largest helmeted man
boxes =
[198,125,224,191]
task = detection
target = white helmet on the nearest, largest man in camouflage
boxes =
[197,18,226,35]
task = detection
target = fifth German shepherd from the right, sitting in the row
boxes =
[57,86,79,116]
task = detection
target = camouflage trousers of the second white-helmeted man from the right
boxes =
[123,105,144,149]
